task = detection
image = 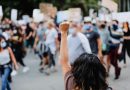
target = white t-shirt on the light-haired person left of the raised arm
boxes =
[45,28,58,54]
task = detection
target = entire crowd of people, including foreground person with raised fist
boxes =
[0,17,130,90]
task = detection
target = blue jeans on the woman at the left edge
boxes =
[1,67,11,90]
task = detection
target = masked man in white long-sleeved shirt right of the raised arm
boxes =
[67,22,91,64]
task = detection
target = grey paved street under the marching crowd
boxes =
[0,51,130,90]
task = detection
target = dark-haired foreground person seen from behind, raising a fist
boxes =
[60,23,111,90]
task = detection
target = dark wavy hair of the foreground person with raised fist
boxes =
[71,53,108,90]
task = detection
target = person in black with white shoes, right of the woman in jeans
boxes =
[10,21,29,76]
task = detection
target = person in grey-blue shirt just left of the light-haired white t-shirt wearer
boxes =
[33,22,49,72]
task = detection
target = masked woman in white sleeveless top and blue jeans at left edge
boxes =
[0,35,18,90]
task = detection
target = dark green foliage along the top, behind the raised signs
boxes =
[0,0,98,16]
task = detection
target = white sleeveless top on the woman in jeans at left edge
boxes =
[0,49,10,65]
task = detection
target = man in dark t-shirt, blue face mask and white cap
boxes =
[83,18,103,62]
